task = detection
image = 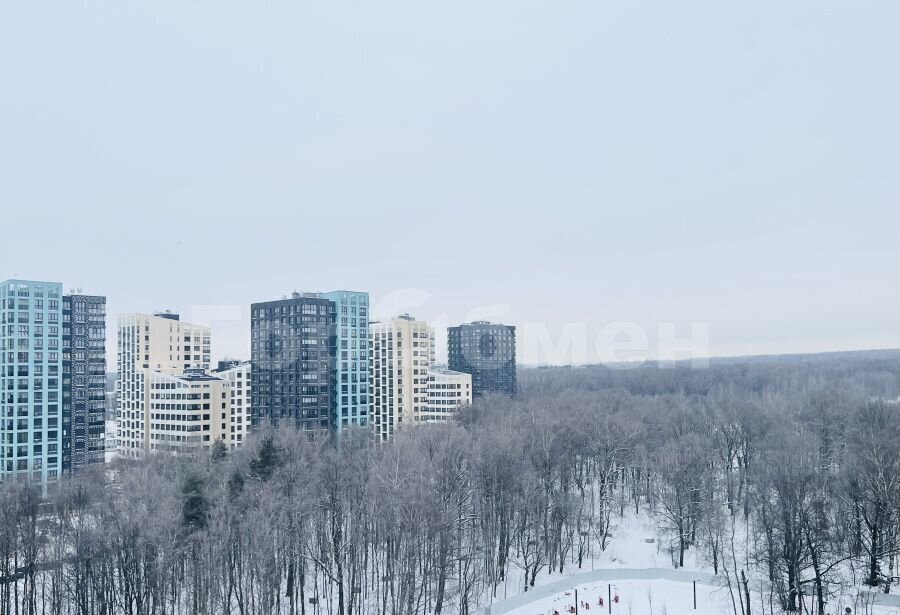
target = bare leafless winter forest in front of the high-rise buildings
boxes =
[0,358,900,615]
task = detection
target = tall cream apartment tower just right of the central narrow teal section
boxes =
[369,314,434,441]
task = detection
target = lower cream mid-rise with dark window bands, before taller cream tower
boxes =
[144,368,231,455]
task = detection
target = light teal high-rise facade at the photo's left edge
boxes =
[0,280,63,485]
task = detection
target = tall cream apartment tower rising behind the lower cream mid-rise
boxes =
[116,313,210,457]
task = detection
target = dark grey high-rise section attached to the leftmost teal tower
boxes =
[62,295,106,474]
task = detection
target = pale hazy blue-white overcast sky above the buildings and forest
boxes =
[0,0,900,362]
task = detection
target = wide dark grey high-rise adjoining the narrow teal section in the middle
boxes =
[250,293,337,433]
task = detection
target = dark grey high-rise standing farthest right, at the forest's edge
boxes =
[447,321,516,397]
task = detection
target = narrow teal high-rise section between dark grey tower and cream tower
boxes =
[322,290,369,433]
